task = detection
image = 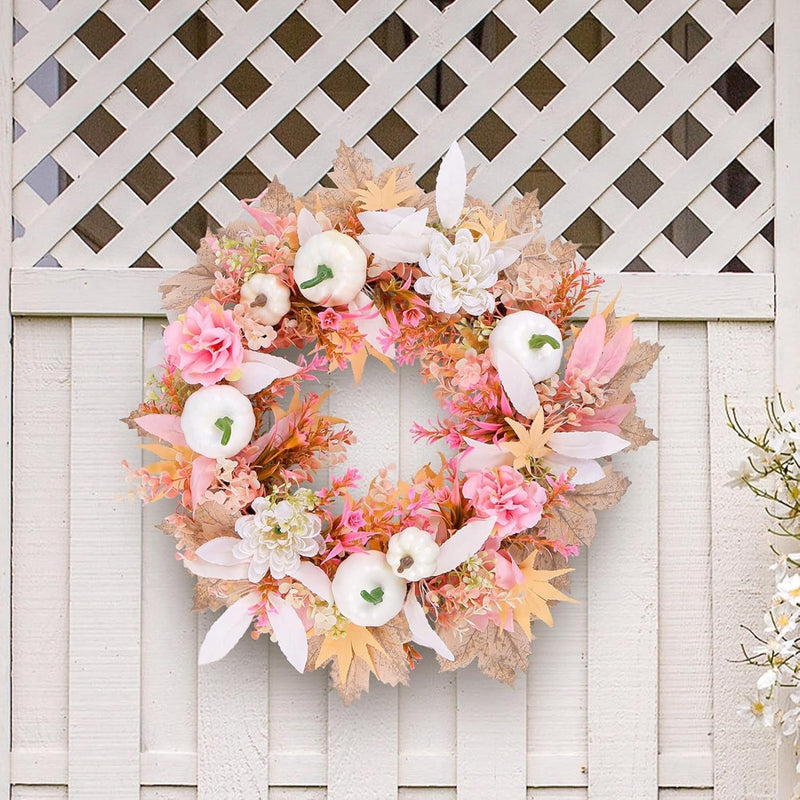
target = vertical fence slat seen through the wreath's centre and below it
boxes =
[328,358,400,800]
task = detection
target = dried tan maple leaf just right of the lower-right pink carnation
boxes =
[537,464,630,545]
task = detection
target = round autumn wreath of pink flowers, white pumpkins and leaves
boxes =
[128,145,658,701]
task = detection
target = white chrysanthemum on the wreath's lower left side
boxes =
[233,489,325,583]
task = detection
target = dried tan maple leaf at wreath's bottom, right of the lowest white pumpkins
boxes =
[438,623,531,686]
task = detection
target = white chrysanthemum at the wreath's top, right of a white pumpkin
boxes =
[414,228,510,316]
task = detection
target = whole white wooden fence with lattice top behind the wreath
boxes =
[0,0,800,800]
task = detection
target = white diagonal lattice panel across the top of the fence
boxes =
[13,0,774,273]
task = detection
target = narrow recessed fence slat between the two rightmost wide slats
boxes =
[658,322,713,786]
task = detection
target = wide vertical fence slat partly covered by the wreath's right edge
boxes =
[584,322,659,800]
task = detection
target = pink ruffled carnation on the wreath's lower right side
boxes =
[461,466,547,537]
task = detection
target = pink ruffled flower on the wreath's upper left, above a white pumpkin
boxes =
[164,300,244,386]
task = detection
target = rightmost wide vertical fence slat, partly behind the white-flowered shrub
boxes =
[708,322,776,800]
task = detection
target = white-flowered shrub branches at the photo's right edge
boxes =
[725,394,800,797]
